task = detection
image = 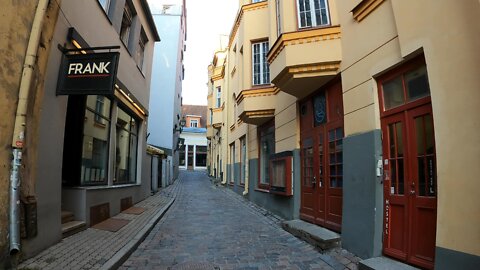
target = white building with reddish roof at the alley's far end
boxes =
[179,105,207,170]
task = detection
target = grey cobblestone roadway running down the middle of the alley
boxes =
[120,171,360,270]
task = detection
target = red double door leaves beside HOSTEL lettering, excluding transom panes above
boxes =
[382,104,437,268]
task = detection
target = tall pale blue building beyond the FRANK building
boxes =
[148,1,187,184]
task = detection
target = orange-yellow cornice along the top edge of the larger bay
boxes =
[267,25,341,64]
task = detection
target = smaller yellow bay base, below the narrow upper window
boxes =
[236,86,279,125]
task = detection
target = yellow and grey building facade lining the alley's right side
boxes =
[207,0,480,269]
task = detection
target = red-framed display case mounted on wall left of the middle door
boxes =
[270,151,293,196]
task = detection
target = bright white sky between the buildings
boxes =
[149,0,238,105]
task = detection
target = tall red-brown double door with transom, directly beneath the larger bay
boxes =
[300,82,343,231]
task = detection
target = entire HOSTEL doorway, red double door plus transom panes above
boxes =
[379,58,437,269]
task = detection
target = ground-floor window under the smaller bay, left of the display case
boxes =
[258,121,275,190]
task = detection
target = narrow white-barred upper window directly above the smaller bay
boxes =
[252,41,270,85]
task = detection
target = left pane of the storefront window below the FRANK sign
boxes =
[80,95,111,185]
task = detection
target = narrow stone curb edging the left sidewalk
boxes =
[100,197,175,270]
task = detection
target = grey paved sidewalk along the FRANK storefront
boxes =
[18,183,179,270]
